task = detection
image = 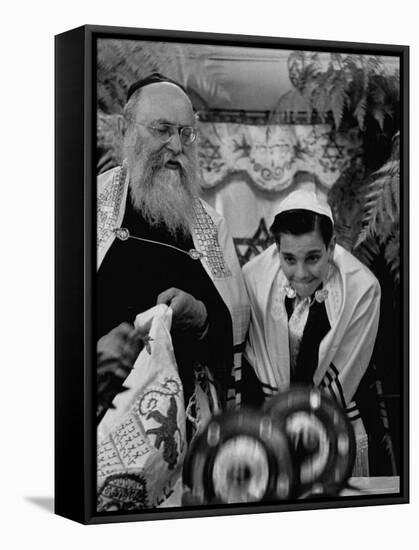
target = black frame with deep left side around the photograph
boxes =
[55,25,409,524]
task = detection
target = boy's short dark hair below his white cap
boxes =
[271,208,333,248]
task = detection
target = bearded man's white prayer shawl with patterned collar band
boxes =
[97,167,249,352]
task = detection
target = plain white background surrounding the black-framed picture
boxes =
[0,0,419,550]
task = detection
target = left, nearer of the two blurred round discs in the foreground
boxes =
[184,410,294,504]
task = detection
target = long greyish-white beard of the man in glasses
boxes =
[128,144,198,237]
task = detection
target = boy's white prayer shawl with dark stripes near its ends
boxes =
[243,244,381,474]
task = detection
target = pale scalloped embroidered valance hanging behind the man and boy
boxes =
[198,122,361,192]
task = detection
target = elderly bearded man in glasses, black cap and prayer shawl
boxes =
[96,74,248,430]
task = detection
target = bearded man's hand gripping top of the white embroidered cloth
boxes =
[157,288,208,338]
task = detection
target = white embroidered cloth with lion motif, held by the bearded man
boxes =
[97,304,186,511]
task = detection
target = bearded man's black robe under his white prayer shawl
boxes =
[96,195,233,410]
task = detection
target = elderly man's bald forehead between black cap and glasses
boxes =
[136,82,194,124]
